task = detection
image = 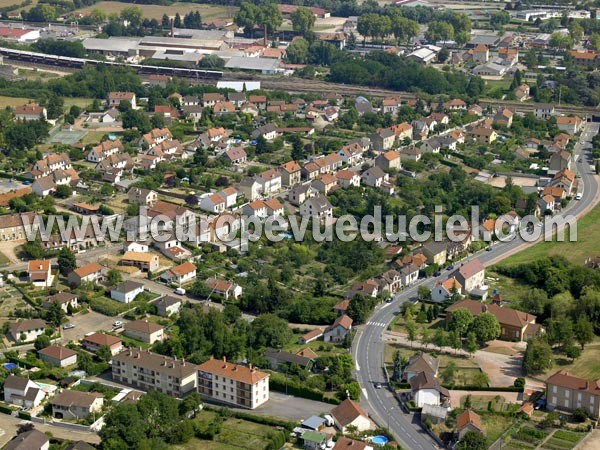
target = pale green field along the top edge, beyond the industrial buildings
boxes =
[74,2,238,22]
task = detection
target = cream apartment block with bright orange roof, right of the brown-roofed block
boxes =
[198,357,269,409]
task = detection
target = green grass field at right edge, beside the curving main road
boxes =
[498,200,600,266]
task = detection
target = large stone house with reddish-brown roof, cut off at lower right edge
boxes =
[546,370,600,419]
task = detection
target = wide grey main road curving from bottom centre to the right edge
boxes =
[352,123,599,450]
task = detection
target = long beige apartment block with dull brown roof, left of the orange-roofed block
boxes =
[112,349,198,397]
